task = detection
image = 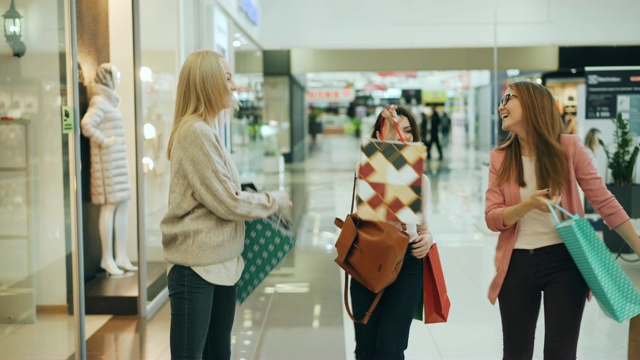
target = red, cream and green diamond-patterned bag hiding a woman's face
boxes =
[356,140,427,224]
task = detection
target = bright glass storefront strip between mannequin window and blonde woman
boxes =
[136,0,180,315]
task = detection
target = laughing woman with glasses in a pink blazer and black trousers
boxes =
[485,82,640,359]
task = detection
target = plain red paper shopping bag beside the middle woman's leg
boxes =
[422,244,451,324]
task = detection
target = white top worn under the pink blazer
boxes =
[514,156,562,250]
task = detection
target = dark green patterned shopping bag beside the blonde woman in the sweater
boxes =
[236,216,296,304]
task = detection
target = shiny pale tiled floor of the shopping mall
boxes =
[0,133,640,360]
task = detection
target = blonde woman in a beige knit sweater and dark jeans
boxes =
[160,51,292,359]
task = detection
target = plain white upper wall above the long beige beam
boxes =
[260,0,640,49]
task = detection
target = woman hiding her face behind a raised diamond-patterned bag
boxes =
[350,105,433,360]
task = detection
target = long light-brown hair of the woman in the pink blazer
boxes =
[498,81,568,195]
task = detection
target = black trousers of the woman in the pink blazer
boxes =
[498,244,589,360]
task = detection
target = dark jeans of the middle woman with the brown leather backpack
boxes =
[351,244,422,360]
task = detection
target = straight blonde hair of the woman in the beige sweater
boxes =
[167,50,231,160]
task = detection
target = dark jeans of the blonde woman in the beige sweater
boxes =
[167,265,236,360]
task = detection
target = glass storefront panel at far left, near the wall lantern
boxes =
[0,0,82,359]
